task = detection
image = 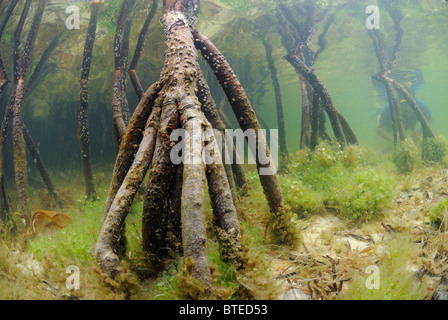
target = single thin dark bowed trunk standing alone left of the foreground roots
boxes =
[78,2,100,199]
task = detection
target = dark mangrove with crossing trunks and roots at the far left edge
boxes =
[0,0,62,221]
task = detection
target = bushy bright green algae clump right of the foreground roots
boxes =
[281,142,396,221]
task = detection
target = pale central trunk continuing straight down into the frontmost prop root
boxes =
[161,6,211,292]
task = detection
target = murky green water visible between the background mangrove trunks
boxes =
[1,1,448,168]
